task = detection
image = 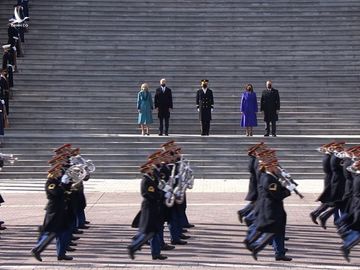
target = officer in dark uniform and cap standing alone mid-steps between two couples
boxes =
[196,80,214,136]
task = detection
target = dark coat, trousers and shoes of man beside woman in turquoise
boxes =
[154,86,173,135]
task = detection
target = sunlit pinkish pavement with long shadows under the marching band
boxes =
[0,192,360,270]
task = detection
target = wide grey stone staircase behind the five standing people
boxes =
[0,0,360,190]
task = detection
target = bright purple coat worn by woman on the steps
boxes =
[240,91,258,127]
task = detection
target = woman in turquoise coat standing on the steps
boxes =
[137,83,154,135]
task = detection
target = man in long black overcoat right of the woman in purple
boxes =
[260,81,280,137]
